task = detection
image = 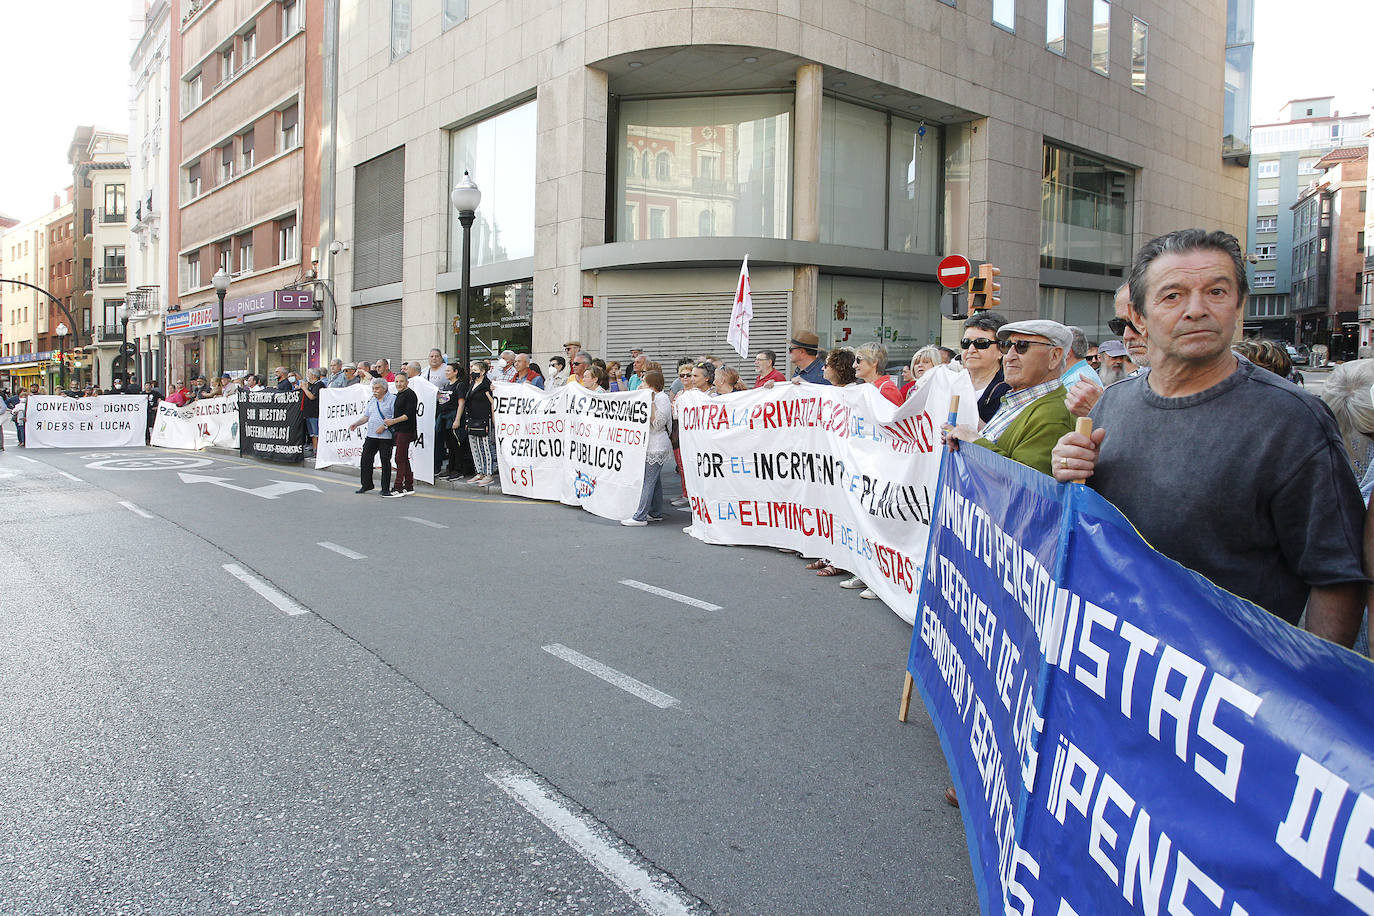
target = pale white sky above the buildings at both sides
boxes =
[0,0,1374,220]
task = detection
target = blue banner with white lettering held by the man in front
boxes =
[907,448,1374,916]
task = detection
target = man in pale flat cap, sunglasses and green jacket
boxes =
[945,319,1073,474]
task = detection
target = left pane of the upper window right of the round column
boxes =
[820,96,888,249]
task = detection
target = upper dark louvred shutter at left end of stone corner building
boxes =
[353,147,405,290]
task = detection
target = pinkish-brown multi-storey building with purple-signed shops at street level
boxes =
[162,0,327,385]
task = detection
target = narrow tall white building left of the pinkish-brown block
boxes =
[125,0,172,386]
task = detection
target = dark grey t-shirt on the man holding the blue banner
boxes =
[1088,358,1364,623]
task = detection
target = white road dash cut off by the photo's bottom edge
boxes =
[486,773,697,916]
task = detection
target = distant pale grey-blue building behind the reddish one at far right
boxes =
[1245,96,1370,345]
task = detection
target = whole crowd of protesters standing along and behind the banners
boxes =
[0,229,1374,667]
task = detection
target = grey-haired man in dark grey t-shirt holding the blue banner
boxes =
[1052,229,1366,645]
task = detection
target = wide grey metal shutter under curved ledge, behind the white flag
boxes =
[596,290,791,385]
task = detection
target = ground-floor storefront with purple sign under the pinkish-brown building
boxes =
[165,290,320,382]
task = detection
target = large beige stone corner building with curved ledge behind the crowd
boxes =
[322,0,1248,378]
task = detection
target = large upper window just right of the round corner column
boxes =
[820,96,944,254]
